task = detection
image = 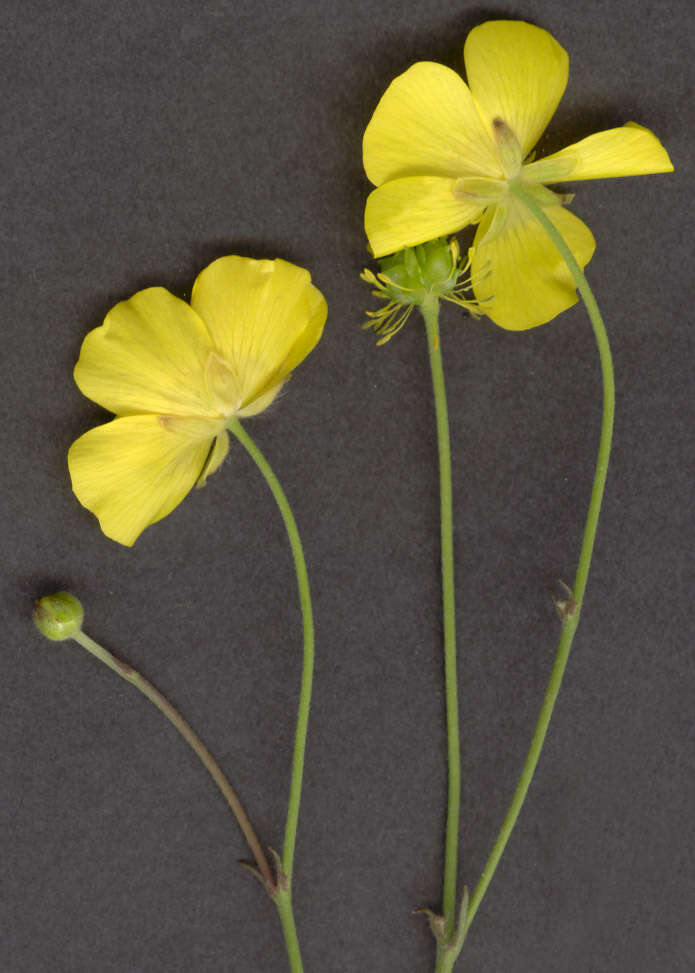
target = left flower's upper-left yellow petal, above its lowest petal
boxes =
[75,287,214,416]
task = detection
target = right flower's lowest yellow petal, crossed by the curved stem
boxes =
[471,197,596,331]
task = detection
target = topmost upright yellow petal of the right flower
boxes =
[463,20,569,155]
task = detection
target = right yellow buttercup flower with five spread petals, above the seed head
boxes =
[364,20,673,330]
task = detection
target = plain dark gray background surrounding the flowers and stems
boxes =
[0,0,695,973]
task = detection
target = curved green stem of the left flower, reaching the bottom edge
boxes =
[227,419,314,973]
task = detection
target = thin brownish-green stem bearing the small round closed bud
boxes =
[72,631,275,890]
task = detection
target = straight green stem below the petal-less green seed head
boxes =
[420,297,461,939]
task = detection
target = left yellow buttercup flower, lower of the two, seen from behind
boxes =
[68,257,326,546]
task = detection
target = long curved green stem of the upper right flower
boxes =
[465,183,615,931]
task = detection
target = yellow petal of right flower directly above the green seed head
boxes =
[364,176,483,257]
